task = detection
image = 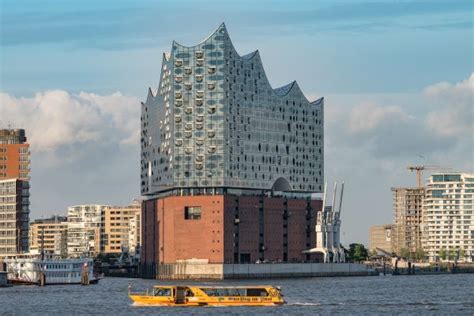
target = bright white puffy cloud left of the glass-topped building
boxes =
[0,90,140,152]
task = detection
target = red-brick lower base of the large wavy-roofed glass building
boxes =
[141,195,322,277]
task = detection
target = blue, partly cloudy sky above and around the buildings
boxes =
[0,0,474,243]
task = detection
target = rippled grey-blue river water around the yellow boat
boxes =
[0,274,474,315]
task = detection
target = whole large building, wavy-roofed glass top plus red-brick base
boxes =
[141,24,324,275]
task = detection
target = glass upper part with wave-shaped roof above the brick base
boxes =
[141,24,324,195]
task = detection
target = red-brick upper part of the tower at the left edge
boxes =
[0,129,30,181]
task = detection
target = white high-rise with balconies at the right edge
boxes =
[423,173,474,262]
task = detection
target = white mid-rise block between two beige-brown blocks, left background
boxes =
[67,205,107,258]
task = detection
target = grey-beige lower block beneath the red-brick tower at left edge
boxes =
[0,179,30,258]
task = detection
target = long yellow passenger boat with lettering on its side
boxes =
[128,285,285,306]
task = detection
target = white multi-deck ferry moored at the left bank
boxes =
[3,255,99,285]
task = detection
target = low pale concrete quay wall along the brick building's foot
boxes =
[156,263,377,280]
